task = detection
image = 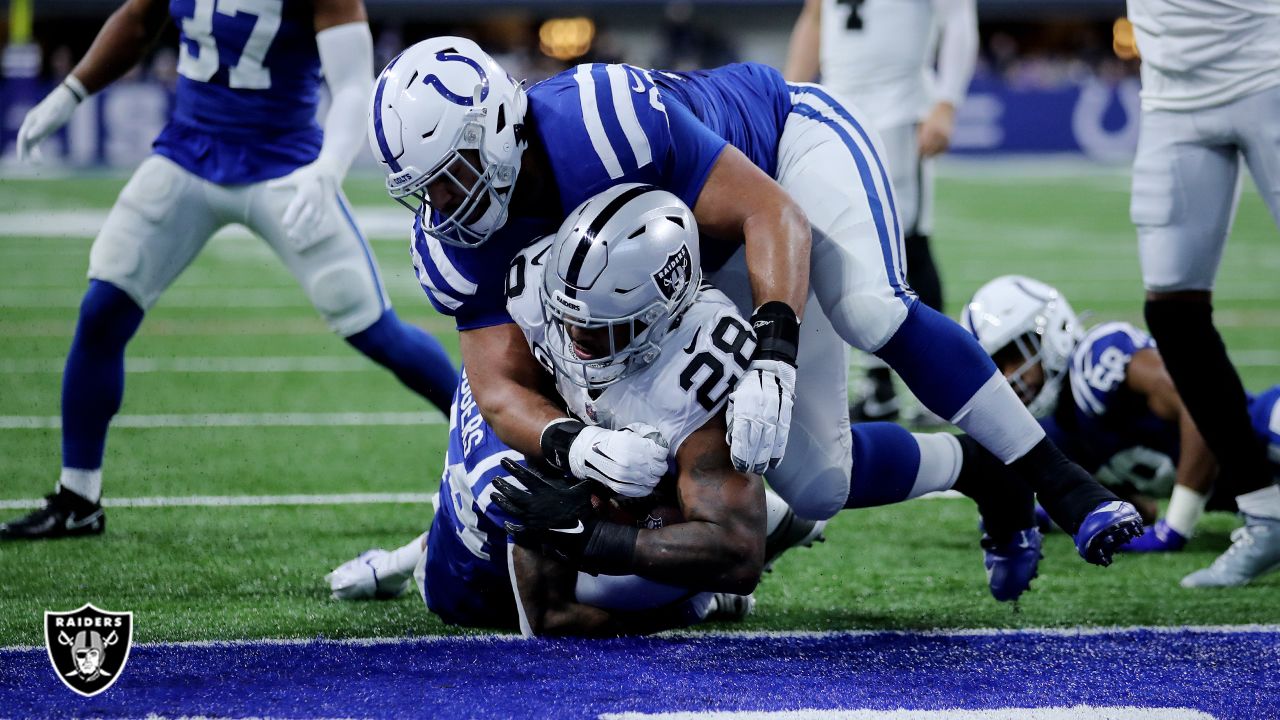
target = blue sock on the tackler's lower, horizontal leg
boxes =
[845,423,920,507]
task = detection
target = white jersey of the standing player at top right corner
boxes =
[1129,0,1280,110]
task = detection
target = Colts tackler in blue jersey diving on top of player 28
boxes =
[369,37,1142,565]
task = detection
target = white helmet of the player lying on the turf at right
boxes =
[960,275,1083,416]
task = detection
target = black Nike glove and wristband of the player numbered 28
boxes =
[493,459,639,573]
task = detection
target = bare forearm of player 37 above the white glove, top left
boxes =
[72,1,168,94]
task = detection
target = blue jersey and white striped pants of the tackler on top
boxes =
[413,63,931,518]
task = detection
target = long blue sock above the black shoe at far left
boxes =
[63,281,143,470]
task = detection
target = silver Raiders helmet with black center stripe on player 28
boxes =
[541,183,703,389]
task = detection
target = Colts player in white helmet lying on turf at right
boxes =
[961,275,1280,587]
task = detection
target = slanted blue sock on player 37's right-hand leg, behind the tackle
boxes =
[347,310,458,415]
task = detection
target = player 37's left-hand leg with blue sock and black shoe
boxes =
[0,155,219,538]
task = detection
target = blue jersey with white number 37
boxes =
[155,0,323,184]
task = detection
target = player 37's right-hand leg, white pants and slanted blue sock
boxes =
[242,183,458,413]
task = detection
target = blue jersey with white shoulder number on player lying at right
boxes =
[1041,323,1280,484]
